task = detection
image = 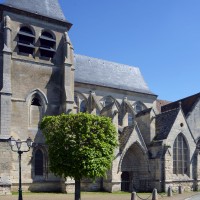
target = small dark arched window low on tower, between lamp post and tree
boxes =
[35,149,44,176]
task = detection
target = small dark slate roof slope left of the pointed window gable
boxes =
[154,108,180,140]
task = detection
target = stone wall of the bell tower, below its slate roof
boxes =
[0,7,74,192]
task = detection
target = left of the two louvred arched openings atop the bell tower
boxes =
[17,26,35,54]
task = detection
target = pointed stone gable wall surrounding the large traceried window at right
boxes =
[165,112,196,191]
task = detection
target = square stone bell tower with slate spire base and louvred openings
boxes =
[0,0,74,194]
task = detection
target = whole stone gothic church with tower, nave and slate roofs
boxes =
[0,0,200,194]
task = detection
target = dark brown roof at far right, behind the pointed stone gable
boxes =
[161,93,200,117]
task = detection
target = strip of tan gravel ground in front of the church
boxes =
[0,192,197,200]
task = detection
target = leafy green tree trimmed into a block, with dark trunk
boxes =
[40,113,118,200]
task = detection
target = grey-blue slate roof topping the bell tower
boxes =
[3,0,65,20]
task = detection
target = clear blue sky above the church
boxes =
[0,0,200,101]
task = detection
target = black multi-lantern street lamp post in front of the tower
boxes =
[8,137,33,200]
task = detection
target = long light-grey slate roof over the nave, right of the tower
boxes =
[74,55,155,95]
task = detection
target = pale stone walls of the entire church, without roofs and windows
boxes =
[0,0,200,195]
